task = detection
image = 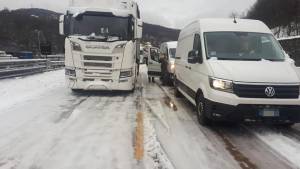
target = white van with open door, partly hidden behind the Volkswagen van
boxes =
[160,41,177,84]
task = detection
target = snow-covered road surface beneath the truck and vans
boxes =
[0,66,300,169]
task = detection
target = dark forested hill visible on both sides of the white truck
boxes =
[0,8,179,53]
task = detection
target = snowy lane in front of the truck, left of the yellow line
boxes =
[0,71,137,169]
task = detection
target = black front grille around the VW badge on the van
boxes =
[233,84,299,99]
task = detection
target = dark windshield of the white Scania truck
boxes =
[70,14,133,41]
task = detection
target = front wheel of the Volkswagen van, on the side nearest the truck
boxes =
[196,96,212,126]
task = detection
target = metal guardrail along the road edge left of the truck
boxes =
[0,55,65,79]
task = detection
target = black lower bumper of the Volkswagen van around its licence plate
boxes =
[206,100,300,123]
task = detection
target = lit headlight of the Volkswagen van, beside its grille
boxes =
[209,77,233,93]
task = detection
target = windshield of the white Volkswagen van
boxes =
[204,32,284,61]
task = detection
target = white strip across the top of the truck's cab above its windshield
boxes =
[68,7,132,17]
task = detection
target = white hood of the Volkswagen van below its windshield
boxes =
[208,60,300,84]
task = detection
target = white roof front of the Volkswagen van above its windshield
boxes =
[180,18,272,37]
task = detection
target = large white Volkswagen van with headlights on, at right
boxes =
[175,19,300,126]
